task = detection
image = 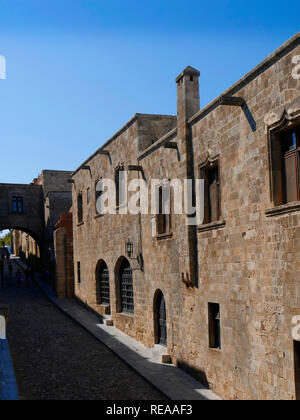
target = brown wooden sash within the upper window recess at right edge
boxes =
[281,127,300,204]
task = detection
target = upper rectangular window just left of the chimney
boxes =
[156,186,172,235]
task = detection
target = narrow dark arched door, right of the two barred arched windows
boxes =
[154,290,167,346]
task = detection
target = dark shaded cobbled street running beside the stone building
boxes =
[1,262,164,400]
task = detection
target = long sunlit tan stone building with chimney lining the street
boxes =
[72,33,300,400]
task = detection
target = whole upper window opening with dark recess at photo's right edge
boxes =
[271,126,300,205]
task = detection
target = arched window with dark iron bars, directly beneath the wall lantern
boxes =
[115,257,134,314]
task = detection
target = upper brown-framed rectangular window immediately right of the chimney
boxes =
[201,162,221,223]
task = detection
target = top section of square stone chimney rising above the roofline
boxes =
[176,66,200,121]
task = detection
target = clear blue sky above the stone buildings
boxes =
[0,0,300,183]
